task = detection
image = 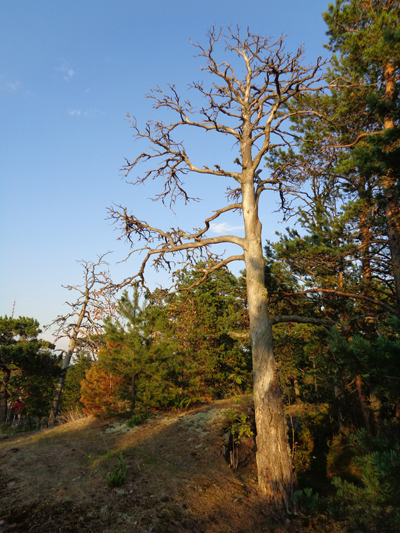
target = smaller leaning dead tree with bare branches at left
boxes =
[47,254,115,425]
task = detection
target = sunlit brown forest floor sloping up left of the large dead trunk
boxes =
[0,397,339,533]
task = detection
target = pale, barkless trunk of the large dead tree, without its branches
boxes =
[242,165,296,511]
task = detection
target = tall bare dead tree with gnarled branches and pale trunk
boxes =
[109,28,322,509]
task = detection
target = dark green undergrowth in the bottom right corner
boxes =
[294,423,400,532]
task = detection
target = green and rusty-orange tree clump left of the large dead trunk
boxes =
[81,266,251,414]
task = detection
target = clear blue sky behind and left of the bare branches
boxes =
[0,0,327,344]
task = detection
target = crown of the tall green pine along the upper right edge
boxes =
[267,0,400,324]
